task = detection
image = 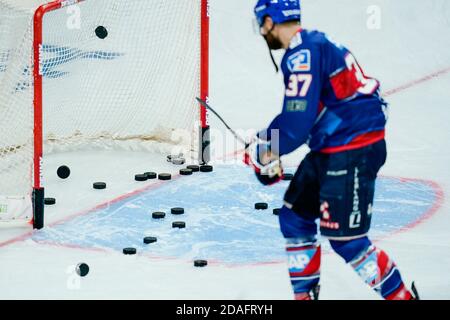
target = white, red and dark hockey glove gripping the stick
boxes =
[244,140,283,186]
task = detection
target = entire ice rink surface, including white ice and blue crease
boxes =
[0,0,450,300]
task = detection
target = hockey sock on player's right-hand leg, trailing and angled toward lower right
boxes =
[331,238,412,300]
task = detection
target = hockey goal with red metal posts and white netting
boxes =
[0,0,209,228]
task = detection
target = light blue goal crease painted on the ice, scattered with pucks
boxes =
[32,165,437,264]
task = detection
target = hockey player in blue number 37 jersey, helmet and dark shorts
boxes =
[245,0,418,300]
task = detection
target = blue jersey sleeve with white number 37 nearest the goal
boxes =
[260,42,322,156]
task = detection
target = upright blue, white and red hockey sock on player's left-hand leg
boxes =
[286,239,321,300]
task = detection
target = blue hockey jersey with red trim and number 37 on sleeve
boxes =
[260,30,387,155]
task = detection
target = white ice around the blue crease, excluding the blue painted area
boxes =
[0,0,450,299]
